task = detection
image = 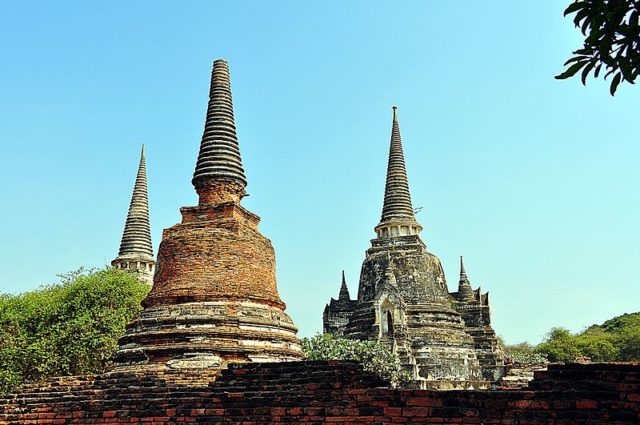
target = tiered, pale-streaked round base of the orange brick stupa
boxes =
[113,301,304,371]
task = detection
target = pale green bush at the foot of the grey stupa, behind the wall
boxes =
[302,334,409,387]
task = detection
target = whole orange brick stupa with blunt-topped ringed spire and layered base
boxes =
[115,60,303,370]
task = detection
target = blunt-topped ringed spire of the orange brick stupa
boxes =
[192,59,247,203]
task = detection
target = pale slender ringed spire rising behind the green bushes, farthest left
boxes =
[111,145,156,285]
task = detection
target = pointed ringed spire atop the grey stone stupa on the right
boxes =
[376,106,422,237]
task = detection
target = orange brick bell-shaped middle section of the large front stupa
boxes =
[143,203,284,308]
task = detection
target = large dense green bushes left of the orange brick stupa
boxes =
[0,267,149,393]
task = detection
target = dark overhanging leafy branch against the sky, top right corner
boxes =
[556,0,640,96]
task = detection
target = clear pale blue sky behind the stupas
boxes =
[0,0,640,342]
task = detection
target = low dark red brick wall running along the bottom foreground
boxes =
[0,362,640,425]
